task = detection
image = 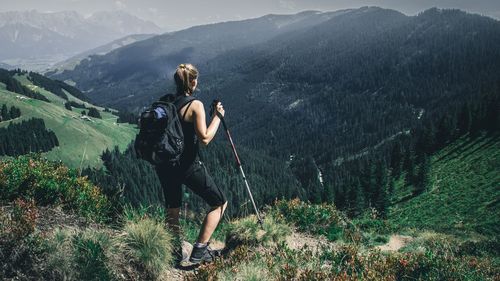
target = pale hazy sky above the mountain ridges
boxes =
[0,0,500,30]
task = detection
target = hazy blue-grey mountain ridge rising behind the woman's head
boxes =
[48,11,347,107]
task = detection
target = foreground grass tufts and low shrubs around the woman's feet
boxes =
[0,151,500,280]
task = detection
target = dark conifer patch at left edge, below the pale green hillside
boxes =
[0,118,59,156]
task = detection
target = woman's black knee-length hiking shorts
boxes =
[156,160,227,208]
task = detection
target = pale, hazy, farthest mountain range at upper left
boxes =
[0,11,162,70]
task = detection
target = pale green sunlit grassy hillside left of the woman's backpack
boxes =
[0,73,138,168]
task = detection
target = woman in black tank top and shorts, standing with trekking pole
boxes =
[156,64,227,264]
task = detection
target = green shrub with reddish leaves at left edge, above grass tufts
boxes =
[0,154,111,222]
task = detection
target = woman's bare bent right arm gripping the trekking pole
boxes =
[191,100,224,145]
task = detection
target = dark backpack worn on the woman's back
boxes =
[134,95,195,164]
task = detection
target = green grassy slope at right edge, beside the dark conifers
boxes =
[389,135,500,236]
